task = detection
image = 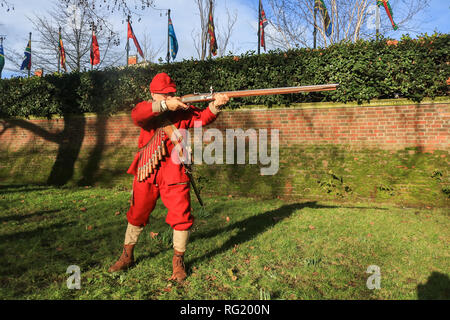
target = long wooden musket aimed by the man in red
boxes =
[181,83,339,103]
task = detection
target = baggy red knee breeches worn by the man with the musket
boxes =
[127,174,194,231]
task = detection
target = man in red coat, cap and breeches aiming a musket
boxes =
[108,73,229,281]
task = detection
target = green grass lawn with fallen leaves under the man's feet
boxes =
[0,185,450,300]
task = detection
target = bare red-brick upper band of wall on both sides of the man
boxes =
[0,103,450,151]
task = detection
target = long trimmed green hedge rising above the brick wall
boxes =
[0,34,450,117]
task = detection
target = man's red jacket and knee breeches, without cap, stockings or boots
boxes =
[127,101,217,230]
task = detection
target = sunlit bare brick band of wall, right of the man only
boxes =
[216,104,450,150]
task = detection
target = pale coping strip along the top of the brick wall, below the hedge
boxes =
[1,96,450,120]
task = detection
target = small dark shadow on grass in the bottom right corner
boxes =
[417,271,450,300]
